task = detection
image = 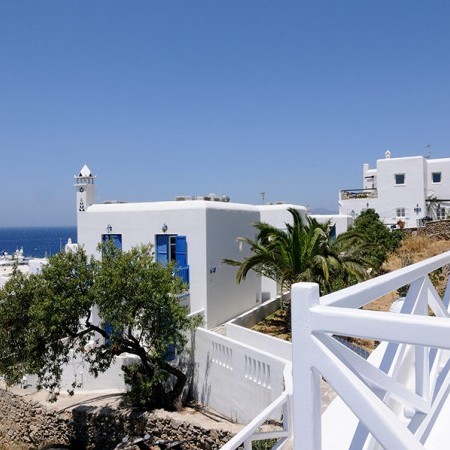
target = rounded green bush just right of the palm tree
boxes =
[346,208,403,272]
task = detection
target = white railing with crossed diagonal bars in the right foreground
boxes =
[292,252,450,450]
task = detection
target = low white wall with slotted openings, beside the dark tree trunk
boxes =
[193,328,286,424]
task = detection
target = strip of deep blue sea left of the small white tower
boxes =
[0,226,77,258]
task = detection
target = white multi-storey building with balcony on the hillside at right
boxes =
[339,151,450,228]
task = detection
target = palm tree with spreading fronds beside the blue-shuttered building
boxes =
[224,208,369,294]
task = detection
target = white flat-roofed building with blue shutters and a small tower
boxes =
[75,166,312,328]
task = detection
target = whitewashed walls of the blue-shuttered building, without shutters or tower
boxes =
[78,200,261,328]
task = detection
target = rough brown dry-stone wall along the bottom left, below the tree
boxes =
[0,389,237,450]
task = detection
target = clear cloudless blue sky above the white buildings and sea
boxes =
[0,0,450,226]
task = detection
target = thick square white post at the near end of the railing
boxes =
[291,283,322,450]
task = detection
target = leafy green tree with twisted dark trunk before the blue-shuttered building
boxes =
[0,243,198,408]
